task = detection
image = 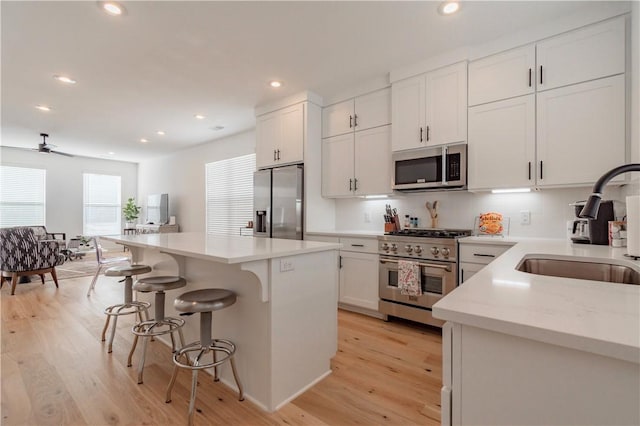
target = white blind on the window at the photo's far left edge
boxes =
[0,166,46,228]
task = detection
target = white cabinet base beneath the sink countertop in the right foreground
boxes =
[441,322,640,425]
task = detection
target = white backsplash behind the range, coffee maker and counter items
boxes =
[336,187,625,238]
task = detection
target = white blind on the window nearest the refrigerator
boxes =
[205,154,256,235]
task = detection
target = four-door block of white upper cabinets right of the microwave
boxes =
[468,18,626,190]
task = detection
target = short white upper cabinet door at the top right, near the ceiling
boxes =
[536,18,625,91]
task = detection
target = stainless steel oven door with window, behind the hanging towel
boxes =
[379,256,456,309]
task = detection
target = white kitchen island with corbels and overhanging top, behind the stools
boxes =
[103,232,340,411]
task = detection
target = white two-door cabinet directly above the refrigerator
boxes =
[256,103,304,168]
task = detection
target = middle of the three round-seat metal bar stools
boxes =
[127,276,187,384]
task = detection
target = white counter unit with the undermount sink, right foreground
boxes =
[433,240,640,425]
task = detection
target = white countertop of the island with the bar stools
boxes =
[101,232,341,264]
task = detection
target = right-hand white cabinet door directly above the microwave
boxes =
[424,62,467,146]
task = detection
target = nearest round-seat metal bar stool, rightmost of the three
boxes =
[166,288,244,425]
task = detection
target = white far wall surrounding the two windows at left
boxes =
[0,147,138,239]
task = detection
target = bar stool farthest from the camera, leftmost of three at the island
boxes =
[102,265,151,354]
